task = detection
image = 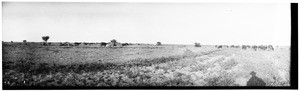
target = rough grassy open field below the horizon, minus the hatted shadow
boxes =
[2,42,290,87]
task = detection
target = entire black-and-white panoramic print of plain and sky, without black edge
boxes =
[2,2,291,89]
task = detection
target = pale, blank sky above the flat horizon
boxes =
[2,2,291,45]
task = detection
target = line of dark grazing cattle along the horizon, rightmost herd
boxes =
[215,45,274,51]
